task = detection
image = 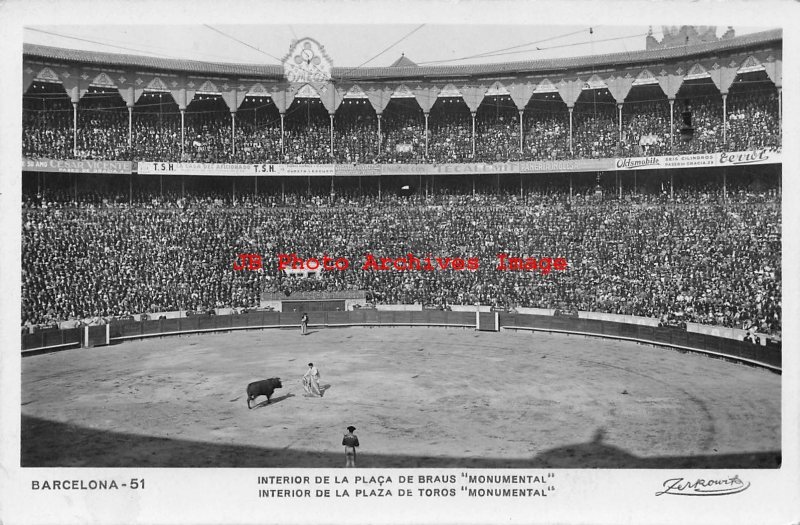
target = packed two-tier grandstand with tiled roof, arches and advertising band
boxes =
[21,27,781,337]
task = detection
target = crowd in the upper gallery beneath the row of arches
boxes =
[22,86,781,163]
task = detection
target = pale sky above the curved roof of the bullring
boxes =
[23,23,771,67]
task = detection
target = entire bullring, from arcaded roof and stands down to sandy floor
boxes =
[19,26,788,469]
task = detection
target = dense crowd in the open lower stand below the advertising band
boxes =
[21,181,781,333]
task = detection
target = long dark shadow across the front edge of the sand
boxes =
[21,416,781,469]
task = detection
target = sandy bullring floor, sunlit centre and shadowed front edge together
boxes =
[22,328,781,468]
